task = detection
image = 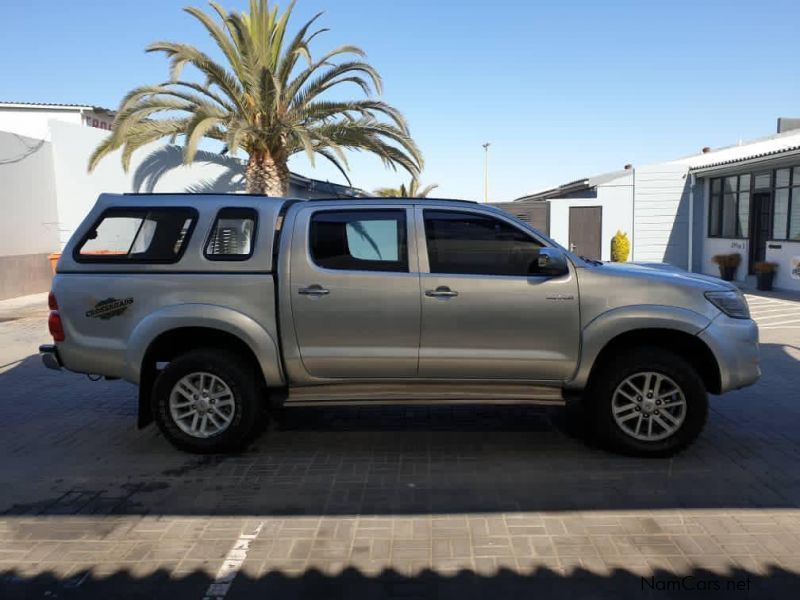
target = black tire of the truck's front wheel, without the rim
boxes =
[585,347,708,457]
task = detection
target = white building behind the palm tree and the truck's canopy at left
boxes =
[0,102,363,299]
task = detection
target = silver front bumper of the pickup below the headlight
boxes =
[699,314,761,394]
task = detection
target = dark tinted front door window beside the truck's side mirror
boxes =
[424,210,542,276]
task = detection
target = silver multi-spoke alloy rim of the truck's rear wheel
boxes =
[169,372,236,439]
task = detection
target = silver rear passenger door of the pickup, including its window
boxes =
[290,204,420,378]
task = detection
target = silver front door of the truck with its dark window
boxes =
[417,208,580,381]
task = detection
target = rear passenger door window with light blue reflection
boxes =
[309,209,408,272]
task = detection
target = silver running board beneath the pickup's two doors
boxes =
[285,382,565,406]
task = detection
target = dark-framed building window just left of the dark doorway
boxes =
[708,173,752,238]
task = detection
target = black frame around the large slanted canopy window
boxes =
[72,206,200,265]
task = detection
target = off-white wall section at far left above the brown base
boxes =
[0,131,58,256]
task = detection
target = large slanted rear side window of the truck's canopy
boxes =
[75,208,197,263]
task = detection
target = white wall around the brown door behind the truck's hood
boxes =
[549,175,633,260]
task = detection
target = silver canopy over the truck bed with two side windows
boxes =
[58,194,293,273]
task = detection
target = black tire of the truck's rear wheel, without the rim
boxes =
[153,348,265,454]
